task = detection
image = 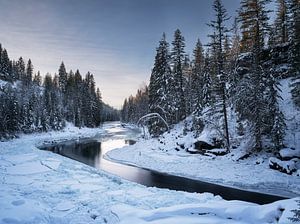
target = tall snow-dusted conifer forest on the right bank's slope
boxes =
[122,0,300,152]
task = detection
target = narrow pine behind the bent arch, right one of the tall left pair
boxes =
[168,29,186,123]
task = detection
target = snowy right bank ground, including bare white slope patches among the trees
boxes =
[106,79,300,197]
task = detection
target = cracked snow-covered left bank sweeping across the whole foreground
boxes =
[0,123,299,224]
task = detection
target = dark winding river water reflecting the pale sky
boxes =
[41,122,285,204]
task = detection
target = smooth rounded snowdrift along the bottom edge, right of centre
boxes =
[113,200,298,224]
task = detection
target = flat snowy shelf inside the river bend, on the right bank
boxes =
[106,132,300,197]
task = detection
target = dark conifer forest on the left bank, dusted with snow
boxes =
[0,44,119,137]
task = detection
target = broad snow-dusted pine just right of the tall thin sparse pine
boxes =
[234,0,273,150]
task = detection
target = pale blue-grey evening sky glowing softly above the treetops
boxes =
[0,0,240,108]
